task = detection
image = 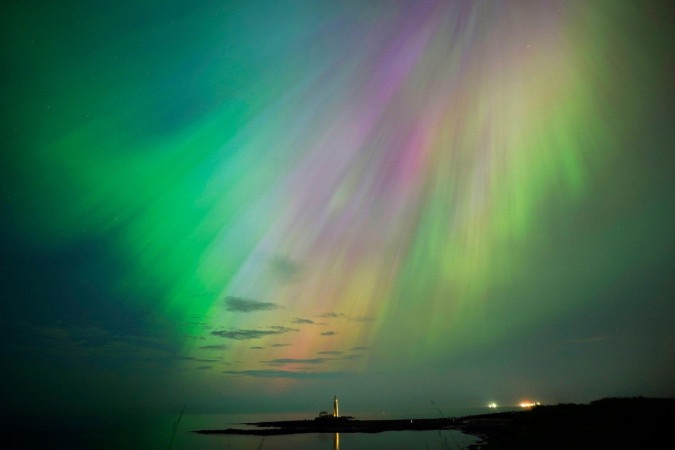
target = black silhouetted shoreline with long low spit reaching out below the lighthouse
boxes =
[196,397,675,450]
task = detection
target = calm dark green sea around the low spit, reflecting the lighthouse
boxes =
[0,407,515,450]
